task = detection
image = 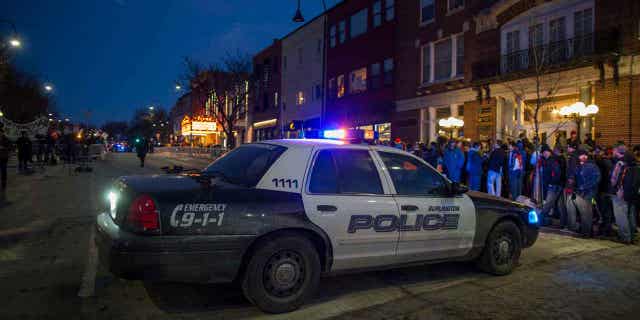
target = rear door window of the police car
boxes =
[309,149,384,194]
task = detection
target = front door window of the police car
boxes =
[379,152,446,195]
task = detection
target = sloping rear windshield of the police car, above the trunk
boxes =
[203,143,287,187]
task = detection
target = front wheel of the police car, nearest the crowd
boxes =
[477,221,522,276]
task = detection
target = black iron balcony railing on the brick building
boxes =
[500,34,595,74]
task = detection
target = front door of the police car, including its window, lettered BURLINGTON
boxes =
[377,151,476,261]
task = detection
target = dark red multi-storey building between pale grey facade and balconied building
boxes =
[325,0,398,140]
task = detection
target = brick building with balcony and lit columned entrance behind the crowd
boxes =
[393,0,640,144]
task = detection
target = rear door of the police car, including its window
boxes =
[303,146,398,270]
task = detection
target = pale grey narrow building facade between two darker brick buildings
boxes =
[279,15,325,138]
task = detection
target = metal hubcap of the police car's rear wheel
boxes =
[263,250,305,298]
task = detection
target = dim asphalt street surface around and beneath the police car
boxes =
[0,154,640,320]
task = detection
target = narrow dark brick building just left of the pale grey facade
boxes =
[248,39,282,141]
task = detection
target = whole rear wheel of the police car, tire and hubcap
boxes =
[242,235,320,313]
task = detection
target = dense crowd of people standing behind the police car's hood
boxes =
[389,131,640,243]
